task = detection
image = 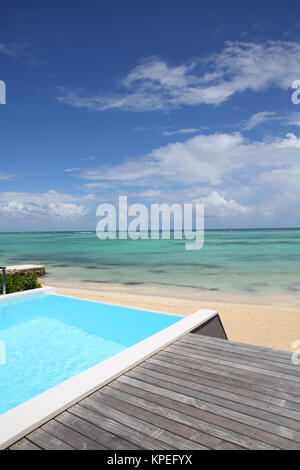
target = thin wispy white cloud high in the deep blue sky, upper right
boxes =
[57,41,300,111]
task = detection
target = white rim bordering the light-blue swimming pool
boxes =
[0,287,217,449]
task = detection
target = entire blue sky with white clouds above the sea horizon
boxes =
[0,0,300,231]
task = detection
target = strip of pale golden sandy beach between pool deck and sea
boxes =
[45,281,300,351]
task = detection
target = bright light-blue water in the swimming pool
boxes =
[0,294,181,414]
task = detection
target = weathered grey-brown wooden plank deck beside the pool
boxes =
[10,334,300,450]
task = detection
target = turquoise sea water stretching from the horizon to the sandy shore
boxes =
[0,229,300,295]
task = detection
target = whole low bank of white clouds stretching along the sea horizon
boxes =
[0,132,300,227]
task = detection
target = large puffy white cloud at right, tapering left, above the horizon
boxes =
[67,133,300,223]
